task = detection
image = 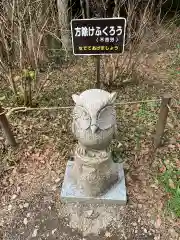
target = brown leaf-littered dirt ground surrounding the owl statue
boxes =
[0,34,180,240]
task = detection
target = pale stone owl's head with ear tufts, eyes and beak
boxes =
[72,89,117,134]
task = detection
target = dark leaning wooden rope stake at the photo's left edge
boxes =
[0,105,17,147]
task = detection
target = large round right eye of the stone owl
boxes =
[97,106,116,130]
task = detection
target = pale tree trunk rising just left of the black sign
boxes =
[57,0,71,53]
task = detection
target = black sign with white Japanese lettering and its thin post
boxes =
[71,18,126,88]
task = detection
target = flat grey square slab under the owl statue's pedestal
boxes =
[61,161,127,205]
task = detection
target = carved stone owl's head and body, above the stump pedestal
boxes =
[72,89,117,152]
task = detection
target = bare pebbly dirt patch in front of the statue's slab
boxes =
[2,189,174,240]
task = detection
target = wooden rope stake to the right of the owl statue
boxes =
[154,94,171,148]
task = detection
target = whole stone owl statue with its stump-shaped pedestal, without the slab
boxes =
[71,89,119,197]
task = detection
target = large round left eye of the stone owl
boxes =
[73,106,91,130]
